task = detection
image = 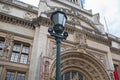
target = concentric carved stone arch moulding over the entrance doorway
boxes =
[50,50,110,80]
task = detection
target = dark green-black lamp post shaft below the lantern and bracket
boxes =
[56,37,61,80]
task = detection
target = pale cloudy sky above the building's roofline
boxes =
[20,0,120,37]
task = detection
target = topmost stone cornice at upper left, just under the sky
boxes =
[0,0,38,14]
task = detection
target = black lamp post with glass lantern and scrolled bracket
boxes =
[48,11,68,80]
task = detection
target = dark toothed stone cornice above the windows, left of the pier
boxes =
[0,12,34,29]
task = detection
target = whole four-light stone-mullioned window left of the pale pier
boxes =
[10,43,30,64]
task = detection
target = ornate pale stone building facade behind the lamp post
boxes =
[0,0,120,80]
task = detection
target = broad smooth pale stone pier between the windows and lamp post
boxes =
[28,26,48,80]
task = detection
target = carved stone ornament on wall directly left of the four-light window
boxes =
[3,34,14,57]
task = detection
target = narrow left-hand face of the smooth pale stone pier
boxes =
[28,26,40,80]
